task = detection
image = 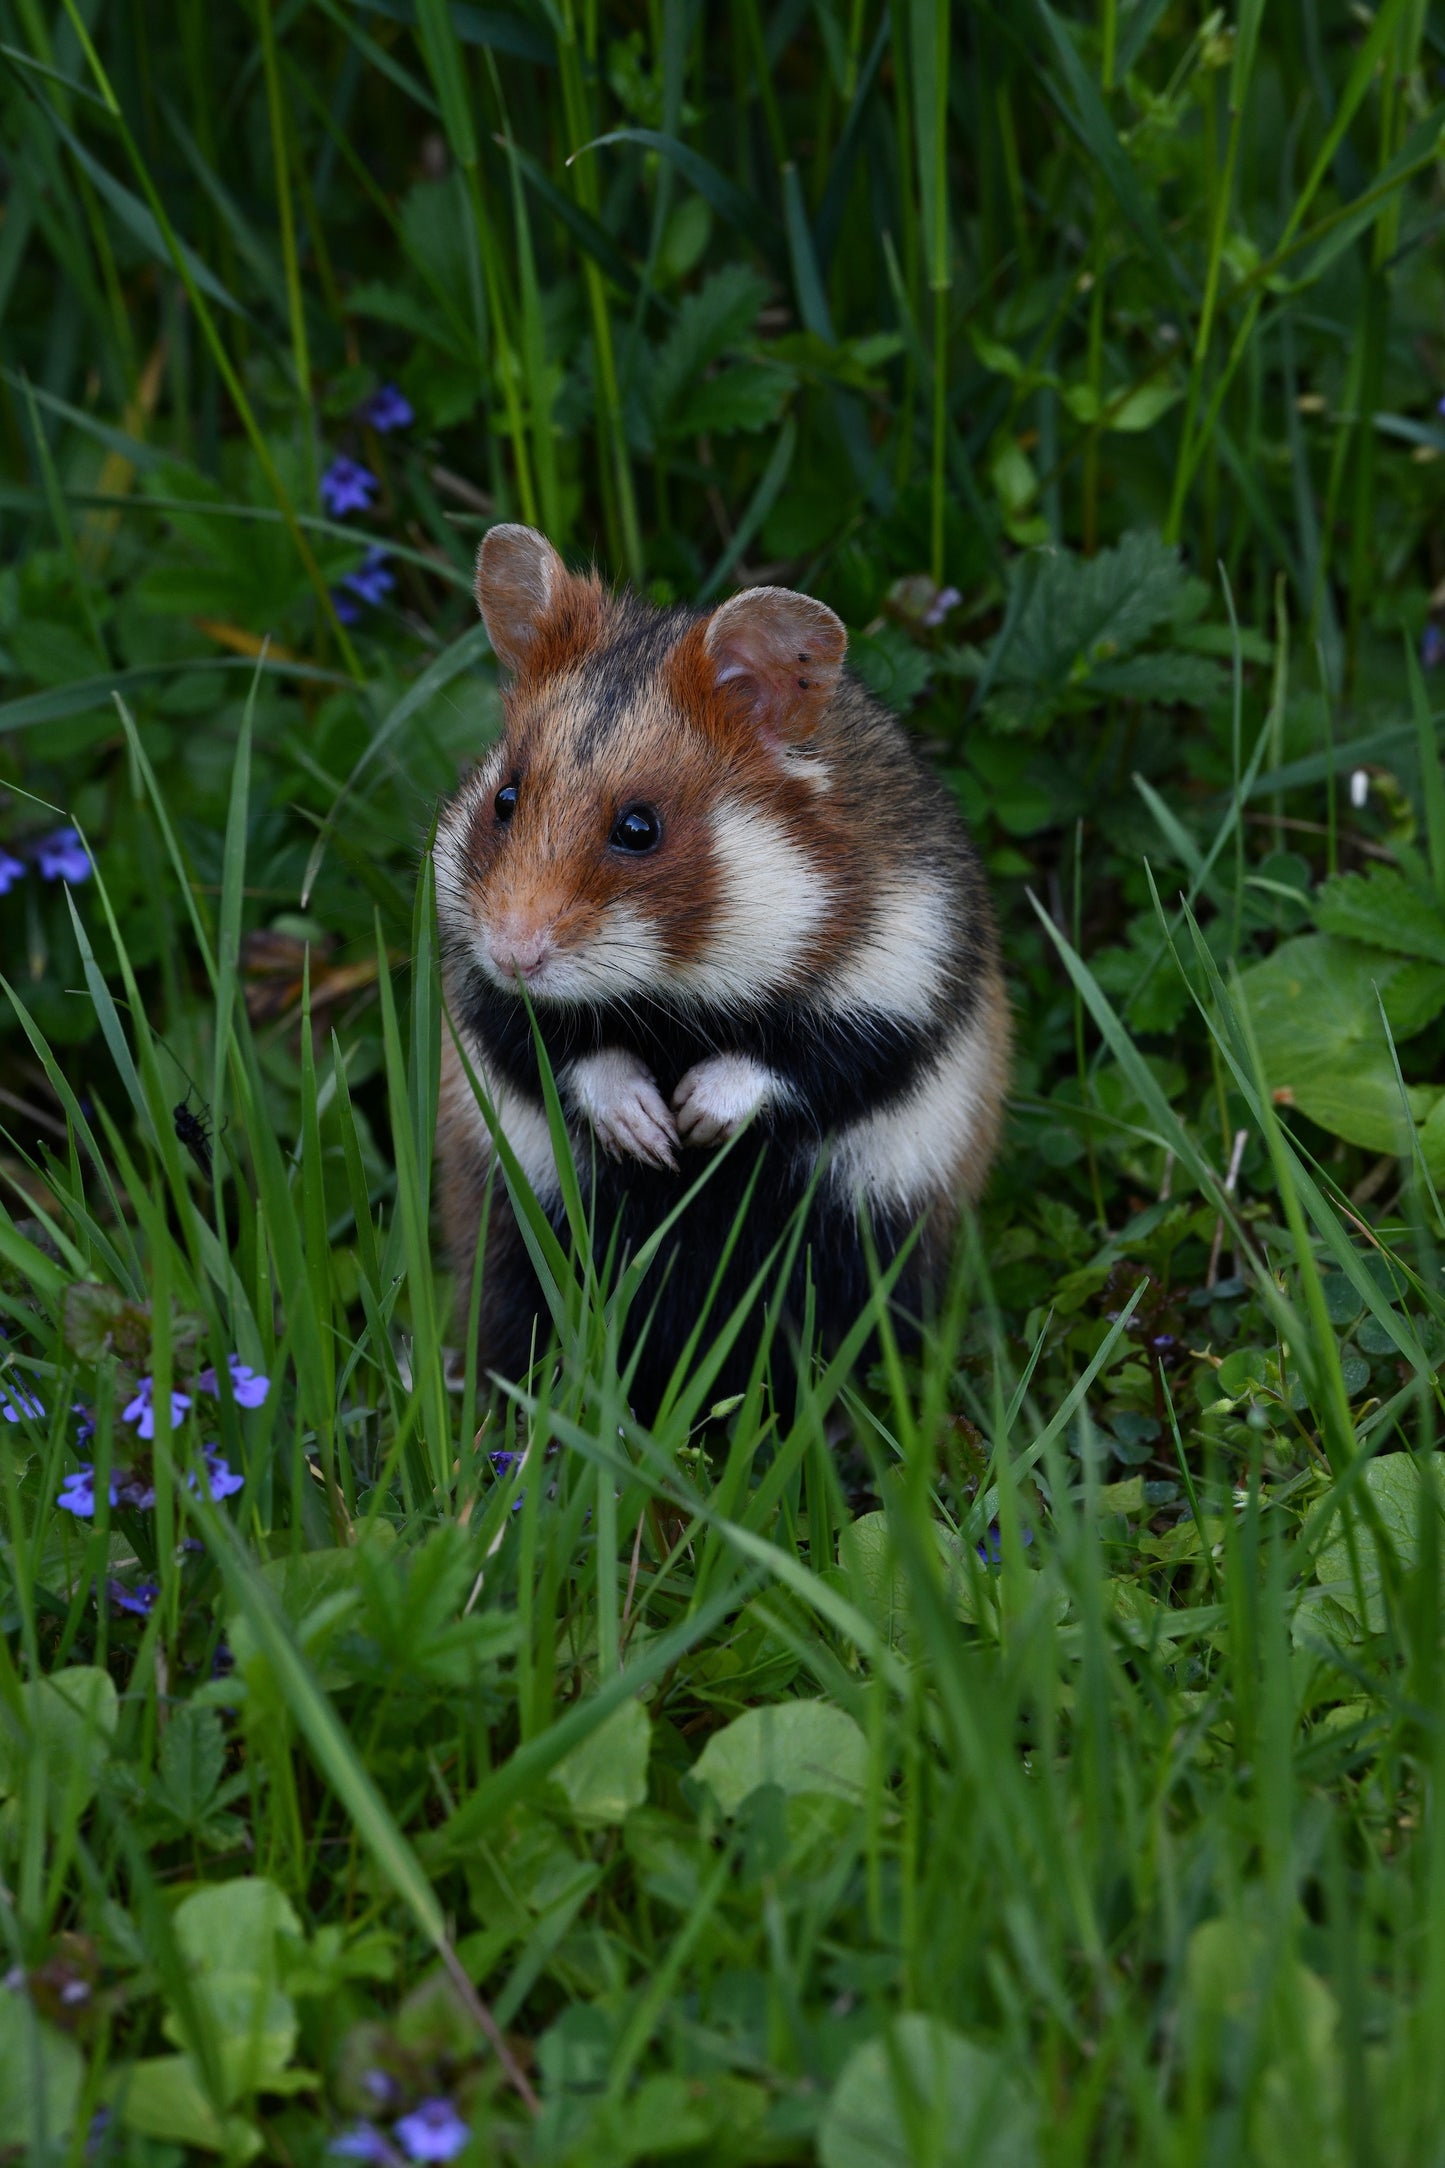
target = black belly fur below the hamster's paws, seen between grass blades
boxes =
[479,1136,921,1422]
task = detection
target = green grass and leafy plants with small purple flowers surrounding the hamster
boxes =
[0,0,1445,2168]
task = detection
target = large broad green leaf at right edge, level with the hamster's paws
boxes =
[1239,934,1445,1151]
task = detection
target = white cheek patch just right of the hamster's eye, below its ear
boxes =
[672,804,830,1006]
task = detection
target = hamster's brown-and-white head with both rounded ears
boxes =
[435,527,847,1008]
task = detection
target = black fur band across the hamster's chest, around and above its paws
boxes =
[459,969,934,1140]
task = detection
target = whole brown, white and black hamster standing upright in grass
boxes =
[433,525,1010,1420]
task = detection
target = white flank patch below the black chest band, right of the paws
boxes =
[830,1019,997,1214]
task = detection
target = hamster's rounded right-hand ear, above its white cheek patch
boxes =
[702,588,847,744]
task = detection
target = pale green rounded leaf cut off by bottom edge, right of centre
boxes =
[819,2010,1038,2168]
